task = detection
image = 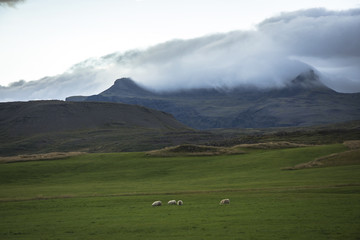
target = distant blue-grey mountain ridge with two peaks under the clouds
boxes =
[66,70,360,129]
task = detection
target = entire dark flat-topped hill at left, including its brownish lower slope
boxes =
[0,101,206,155]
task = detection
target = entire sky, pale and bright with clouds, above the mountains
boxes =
[0,0,360,101]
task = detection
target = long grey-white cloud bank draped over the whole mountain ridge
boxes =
[0,9,360,101]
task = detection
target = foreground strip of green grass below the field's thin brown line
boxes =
[0,191,359,239]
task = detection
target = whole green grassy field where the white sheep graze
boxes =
[0,144,360,239]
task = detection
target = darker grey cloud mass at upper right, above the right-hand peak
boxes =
[258,8,360,92]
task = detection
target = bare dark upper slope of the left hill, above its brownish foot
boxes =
[0,101,186,136]
